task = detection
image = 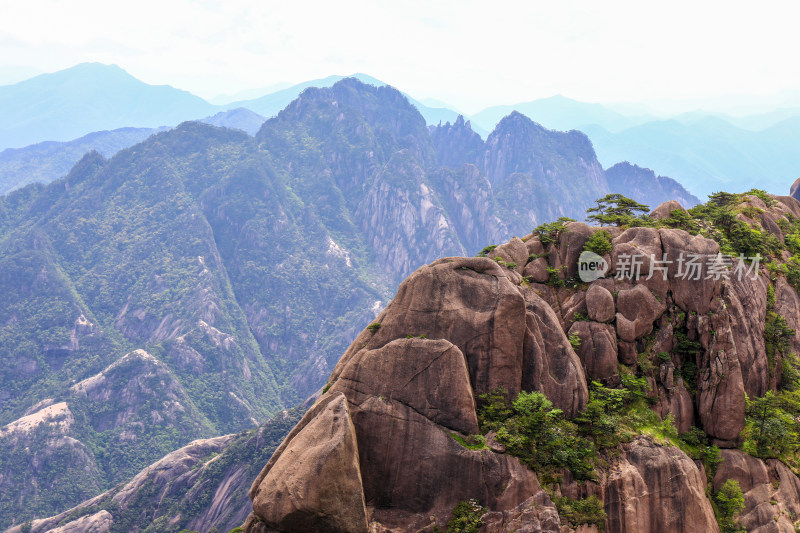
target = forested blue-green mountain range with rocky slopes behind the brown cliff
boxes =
[0,78,697,526]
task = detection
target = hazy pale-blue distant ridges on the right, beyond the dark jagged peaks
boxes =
[470,96,800,198]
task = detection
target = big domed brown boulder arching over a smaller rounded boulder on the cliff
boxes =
[331,257,525,396]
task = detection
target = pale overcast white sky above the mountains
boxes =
[0,0,800,112]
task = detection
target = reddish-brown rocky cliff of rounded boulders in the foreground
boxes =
[244,196,800,533]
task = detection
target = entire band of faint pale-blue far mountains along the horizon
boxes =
[0,63,800,202]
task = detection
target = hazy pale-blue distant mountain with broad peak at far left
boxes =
[0,63,221,149]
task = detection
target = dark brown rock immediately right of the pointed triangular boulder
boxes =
[353,397,541,531]
